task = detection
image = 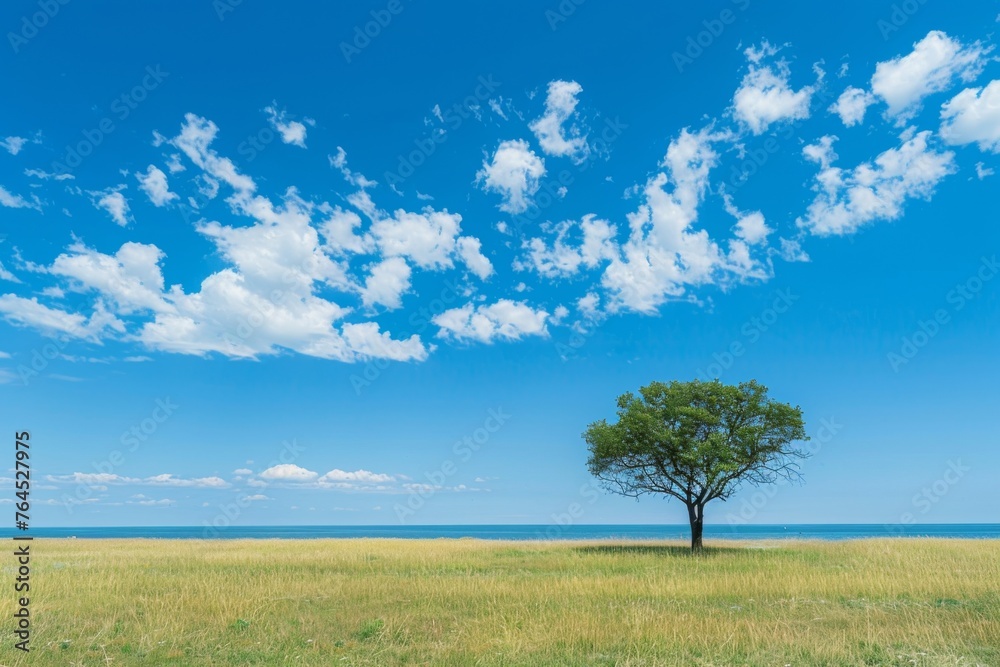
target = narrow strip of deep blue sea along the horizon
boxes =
[0,523,1000,540]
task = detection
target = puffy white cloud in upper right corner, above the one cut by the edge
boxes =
[871,30,989,124]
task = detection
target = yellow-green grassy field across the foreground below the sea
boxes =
[0,539,1000,667]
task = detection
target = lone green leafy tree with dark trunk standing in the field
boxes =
[583,380,809,552]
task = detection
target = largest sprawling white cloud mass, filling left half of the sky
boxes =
[0,124,428,362]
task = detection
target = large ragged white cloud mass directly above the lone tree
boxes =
[515,124,771,318]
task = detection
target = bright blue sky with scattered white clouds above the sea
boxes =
[0,0,1000,526]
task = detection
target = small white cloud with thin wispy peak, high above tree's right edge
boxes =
[733,42,815,134]
